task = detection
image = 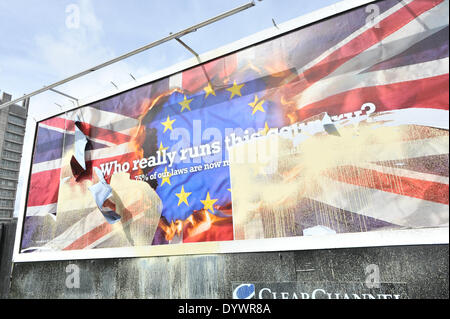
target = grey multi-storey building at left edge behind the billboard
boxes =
[0,92,29,221]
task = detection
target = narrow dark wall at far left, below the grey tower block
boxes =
[0,220,17,299]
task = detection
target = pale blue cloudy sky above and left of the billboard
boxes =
[0,0,342,215]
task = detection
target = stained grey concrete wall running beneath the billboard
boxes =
[10,245,449,298]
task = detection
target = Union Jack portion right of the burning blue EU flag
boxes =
[232,0,449,239]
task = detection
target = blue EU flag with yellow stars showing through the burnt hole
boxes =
[146,67,283,223]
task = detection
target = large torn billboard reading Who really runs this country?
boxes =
[12,0,449,261]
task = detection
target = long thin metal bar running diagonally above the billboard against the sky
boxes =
[0,1,255,110]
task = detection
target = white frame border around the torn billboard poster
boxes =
[13,0,449,263]
